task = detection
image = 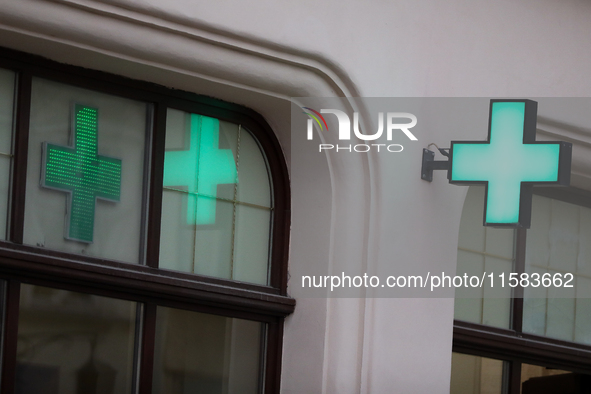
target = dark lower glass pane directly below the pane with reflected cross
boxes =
[152,307,264,394]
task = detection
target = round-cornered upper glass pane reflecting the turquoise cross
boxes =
[160,109,272,284]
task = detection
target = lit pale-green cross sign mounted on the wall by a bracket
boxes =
[448,100,572,228]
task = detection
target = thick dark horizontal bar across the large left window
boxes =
[0,243,295,316]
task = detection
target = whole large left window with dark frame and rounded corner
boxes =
[0,50,295,394]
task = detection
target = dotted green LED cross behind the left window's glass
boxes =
[41,104,121,243]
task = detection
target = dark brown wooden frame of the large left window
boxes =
[0,48,295,394]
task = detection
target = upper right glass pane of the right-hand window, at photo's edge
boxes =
[523,196,591,344]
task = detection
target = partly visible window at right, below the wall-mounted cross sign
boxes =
[451,186,591,394]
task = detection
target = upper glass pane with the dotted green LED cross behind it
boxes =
[24,78,148,263]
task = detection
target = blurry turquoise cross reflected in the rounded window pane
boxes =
[164,114,238,224]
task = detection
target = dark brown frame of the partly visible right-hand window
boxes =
[452,187,591,394]
